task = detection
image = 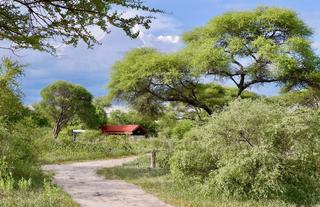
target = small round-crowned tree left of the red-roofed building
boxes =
[40,81,99,138]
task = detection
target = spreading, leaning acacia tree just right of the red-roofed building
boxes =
[109,48,253,116]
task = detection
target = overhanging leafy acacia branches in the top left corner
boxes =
[0,0,161,53]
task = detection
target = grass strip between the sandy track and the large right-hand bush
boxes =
[98,156,294,207]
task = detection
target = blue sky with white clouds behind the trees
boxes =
[0,0,320,104]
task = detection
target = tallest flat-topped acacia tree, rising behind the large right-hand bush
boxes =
[183,7,320,95]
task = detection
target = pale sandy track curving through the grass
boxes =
[43,157,172,207]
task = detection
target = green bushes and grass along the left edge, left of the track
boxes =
[0,58,76,207]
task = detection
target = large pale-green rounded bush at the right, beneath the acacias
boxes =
[171,100,320,203]
